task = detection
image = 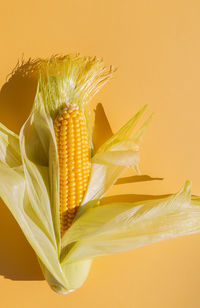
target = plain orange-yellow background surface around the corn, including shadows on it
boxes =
[0,0,200,308]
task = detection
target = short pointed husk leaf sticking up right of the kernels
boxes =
[82,106,150,205]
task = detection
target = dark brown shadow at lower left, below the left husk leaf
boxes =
[0,200,44,280]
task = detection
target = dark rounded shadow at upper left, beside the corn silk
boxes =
[0,59,41,133]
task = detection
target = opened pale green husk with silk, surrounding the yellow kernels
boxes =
[0,56,200,294]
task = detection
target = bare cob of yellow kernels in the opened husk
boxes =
[54,106,91,236]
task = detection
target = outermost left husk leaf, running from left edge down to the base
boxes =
[0,164,68,288]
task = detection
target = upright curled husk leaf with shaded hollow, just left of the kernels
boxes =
[20,113,57,247]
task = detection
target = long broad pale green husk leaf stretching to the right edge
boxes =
[63,181,200,263]
